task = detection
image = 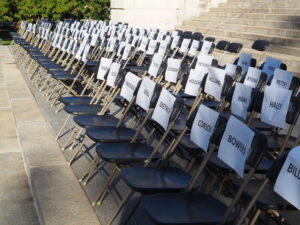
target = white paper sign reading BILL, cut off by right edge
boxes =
[274,146,300,210]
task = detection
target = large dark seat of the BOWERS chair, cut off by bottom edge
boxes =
[141,193,234,225]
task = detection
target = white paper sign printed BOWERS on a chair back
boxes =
[218,116,254,178]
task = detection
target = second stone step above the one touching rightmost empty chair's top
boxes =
[183,16,300,30]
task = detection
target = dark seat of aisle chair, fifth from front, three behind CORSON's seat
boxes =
[73,114,119,128]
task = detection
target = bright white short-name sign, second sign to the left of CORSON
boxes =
[136,77,155,111]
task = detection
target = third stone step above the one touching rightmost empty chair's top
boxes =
[196,12,300,23]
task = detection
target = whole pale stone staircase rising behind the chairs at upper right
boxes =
[177,0,300,75]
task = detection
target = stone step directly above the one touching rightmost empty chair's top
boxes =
[184,21,300,38]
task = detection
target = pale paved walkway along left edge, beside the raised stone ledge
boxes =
[0,46,39,225]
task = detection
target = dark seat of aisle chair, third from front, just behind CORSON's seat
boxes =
[96,142,159,164]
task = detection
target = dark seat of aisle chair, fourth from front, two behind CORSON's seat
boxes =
[86,127,143,143]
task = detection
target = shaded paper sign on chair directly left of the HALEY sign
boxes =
[230,83,252,119]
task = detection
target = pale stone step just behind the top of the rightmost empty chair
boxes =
[177,26,300,47]
